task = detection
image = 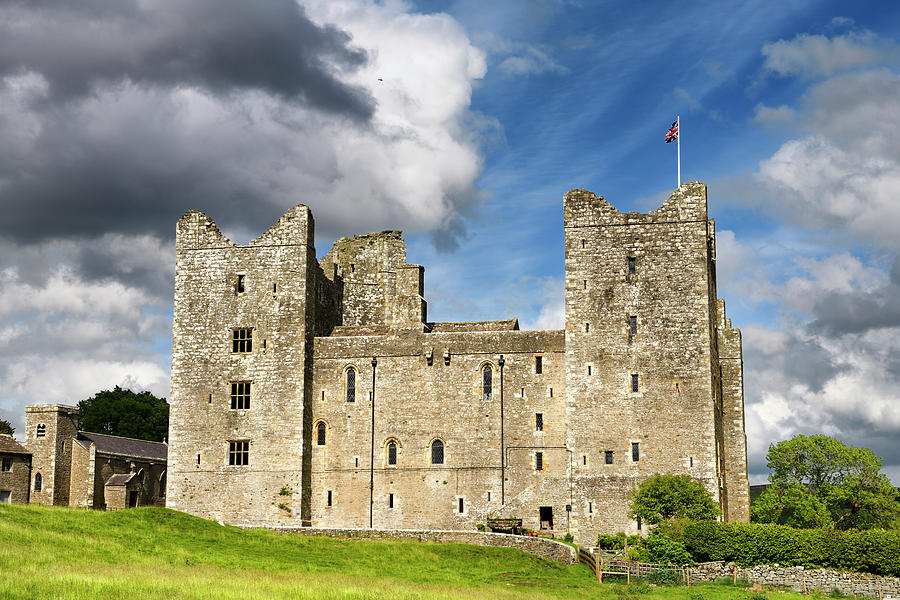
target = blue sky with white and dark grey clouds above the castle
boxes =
[0,0,900,482]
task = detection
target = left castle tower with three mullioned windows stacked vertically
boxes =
[167,206,318,520]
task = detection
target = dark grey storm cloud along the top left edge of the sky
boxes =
[0,0,373,119]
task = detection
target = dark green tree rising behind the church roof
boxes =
[78,386,169,442]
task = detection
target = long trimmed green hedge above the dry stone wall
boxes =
[668,521,900,577]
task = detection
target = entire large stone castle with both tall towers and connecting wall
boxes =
[166,183,749,543]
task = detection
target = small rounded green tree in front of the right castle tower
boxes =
[628,473,719,525]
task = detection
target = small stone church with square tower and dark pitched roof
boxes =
[25,404,168,509]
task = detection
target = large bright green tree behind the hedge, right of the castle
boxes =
[750,434,897,529]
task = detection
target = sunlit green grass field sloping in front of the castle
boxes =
[0,504,832,600]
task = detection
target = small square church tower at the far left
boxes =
[25,404,78,506]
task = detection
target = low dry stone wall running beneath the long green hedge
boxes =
[691,561,900,598]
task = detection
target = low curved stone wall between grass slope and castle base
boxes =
[241,525,576,565]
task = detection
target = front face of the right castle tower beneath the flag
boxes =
[564,184,719,543]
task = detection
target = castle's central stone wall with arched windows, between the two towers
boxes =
[312,330,566,529]
